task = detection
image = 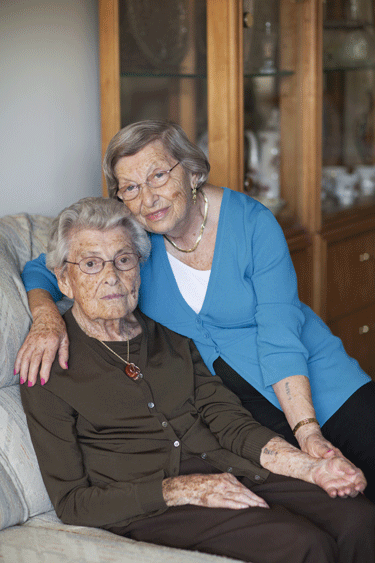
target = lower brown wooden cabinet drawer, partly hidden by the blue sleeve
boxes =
[329,305,375,380]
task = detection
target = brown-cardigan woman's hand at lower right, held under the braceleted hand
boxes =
[311,457,367,498]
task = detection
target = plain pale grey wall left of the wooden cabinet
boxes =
[0,0,101,216]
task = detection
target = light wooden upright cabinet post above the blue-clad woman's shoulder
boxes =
[207,0,244,190]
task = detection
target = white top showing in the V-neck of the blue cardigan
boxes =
[167,252,211,313]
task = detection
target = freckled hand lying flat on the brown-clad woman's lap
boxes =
[163,473,269,510]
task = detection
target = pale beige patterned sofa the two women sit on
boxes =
[0,214,238,563]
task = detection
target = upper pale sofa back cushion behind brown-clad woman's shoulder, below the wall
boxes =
[0,213,52,387]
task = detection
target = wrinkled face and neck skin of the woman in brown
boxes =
[56,227,140,340]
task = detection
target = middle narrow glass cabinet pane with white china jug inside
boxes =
[243,0,299,223]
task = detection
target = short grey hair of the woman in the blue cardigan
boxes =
[103,119,210,198]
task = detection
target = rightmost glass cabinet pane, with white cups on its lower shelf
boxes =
[321,0,375,222]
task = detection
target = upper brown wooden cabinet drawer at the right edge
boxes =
[327,231,375,320]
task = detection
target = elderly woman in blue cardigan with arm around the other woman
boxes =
[15,120,375,501]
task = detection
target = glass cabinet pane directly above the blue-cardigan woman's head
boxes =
[118,0,207,148]
